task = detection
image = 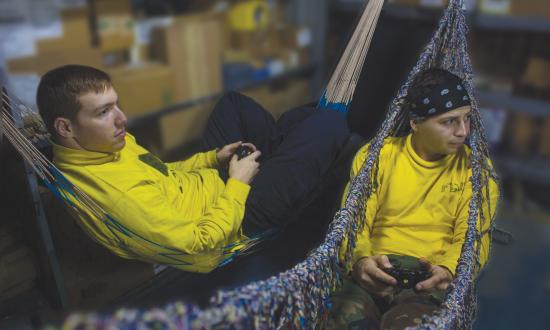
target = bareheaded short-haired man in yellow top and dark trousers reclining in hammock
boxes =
[37,65,349,272]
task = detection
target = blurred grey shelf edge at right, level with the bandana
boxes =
[477,91,550,117]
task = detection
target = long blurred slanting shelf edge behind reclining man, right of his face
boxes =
[128,64,317,128]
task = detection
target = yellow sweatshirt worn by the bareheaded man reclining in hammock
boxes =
[53,135,250,272]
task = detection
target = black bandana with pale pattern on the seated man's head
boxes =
[410,77,471,118]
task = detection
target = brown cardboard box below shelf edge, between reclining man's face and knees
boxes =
[159,102,214,153]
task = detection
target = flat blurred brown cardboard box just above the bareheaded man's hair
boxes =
[7,49,102,75]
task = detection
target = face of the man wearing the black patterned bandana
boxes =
[411,106,472,156]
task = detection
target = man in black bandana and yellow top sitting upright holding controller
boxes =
[330,69,499,329]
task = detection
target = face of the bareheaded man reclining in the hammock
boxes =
[72,87,127,152]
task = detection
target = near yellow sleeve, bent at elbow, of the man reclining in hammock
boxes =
[113,178,250,257]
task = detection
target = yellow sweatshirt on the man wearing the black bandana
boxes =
[342,135,499,274]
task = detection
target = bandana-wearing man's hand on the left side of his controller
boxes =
[352,255,397,297]
